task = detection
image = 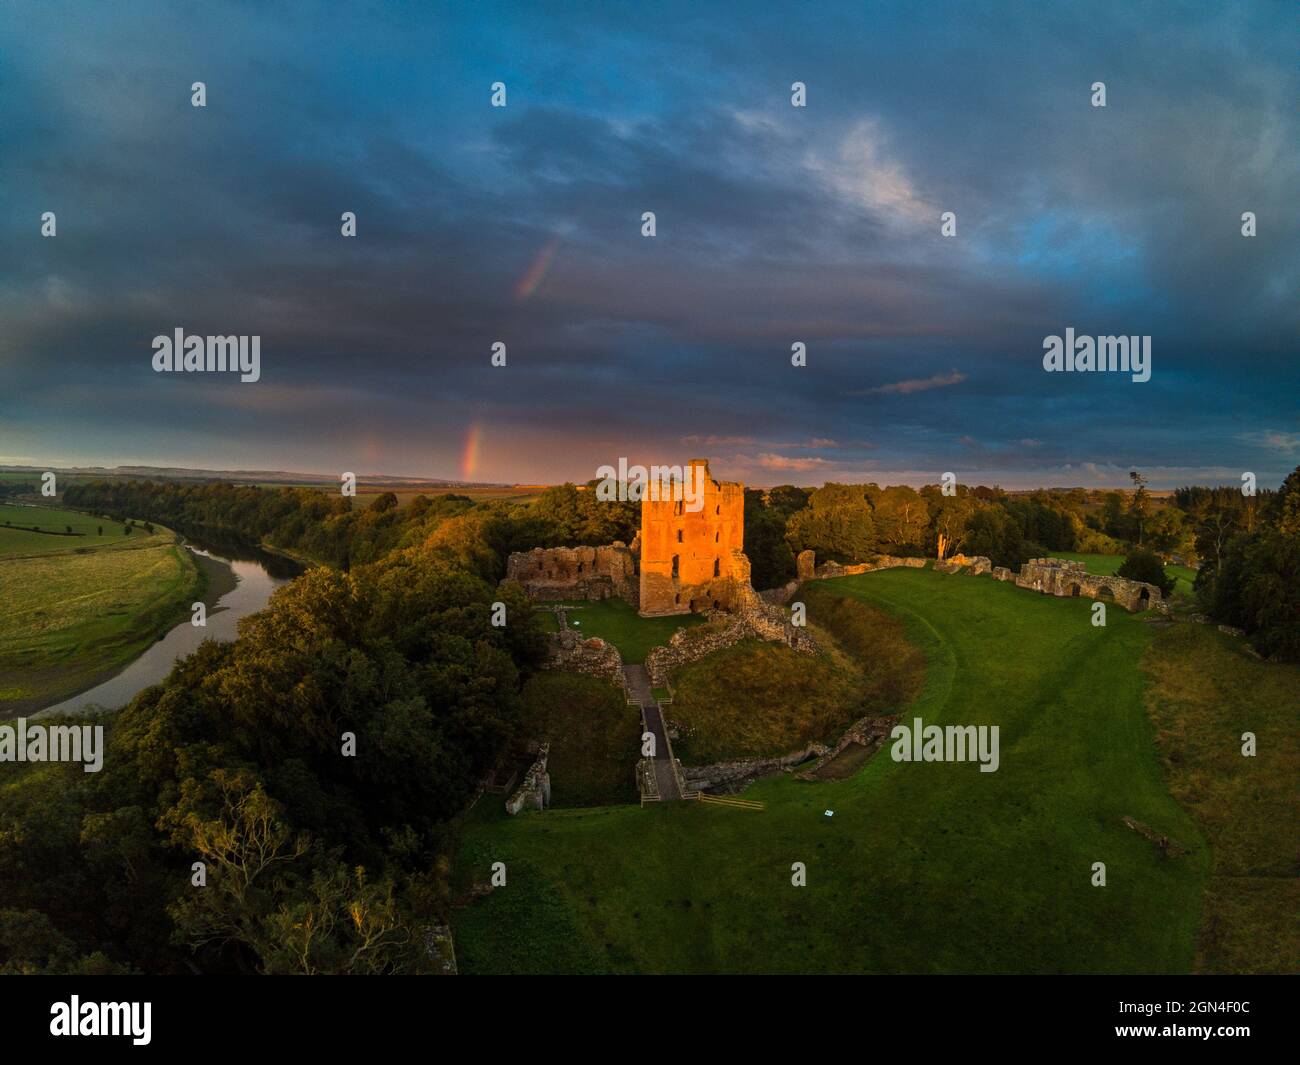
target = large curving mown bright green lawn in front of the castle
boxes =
[452,570,1212,973]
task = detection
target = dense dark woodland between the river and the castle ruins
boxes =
[0,485,595,973]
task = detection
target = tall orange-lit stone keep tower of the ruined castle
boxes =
[641,459,749,618]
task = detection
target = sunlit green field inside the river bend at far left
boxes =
[0,506,204,718]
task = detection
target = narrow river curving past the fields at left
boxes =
[29,531,303,718]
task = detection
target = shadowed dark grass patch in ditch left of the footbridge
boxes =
[523,672,641,806]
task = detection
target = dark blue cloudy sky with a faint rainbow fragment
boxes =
[0,0,1300,488]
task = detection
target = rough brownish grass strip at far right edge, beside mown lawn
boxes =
[1143,624,1300,973]
